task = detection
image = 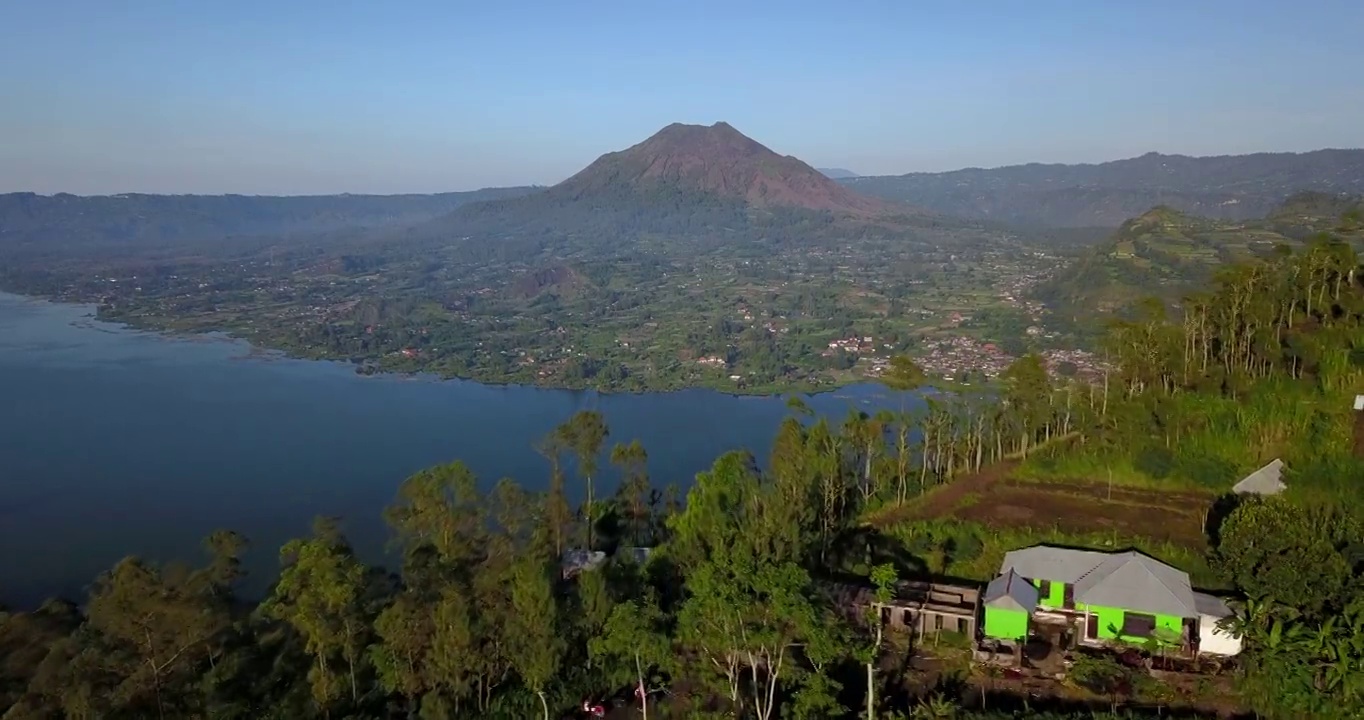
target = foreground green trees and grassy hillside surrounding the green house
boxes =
[0,215,1364,720]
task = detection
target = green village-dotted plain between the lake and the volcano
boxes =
[0,226,1064,394]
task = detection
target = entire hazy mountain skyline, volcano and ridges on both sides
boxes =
[0,133,1364,263]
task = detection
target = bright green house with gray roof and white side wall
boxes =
[981,545,1240,655]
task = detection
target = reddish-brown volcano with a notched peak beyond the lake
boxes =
[405,123,915,262]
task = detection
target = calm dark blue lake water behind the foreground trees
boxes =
[0,293,916,605]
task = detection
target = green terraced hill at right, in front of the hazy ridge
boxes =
[1035,192,1364,318]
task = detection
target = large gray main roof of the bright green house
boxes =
[996,545,1199,618]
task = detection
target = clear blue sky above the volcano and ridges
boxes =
[0,0,1364,194]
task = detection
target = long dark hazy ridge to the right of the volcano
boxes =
[840,150,1364,228]
